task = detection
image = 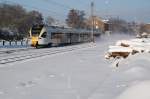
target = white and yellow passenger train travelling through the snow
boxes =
[29,25,101,48]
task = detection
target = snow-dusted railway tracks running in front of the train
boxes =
[0,44,94,65]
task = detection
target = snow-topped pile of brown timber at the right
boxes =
[105,38,150,59]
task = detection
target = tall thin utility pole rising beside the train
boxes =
[91,1,94,42]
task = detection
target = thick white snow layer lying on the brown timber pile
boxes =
[106,38,150,56]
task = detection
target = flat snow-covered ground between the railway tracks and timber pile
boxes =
[0,35,150,99]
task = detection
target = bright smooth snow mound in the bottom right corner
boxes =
[117,81,150,99]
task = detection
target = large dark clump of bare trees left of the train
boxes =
[0,3,43,40]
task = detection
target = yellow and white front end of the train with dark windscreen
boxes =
[29,25,46,47]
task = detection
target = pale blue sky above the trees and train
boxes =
[0,0,150,23]
